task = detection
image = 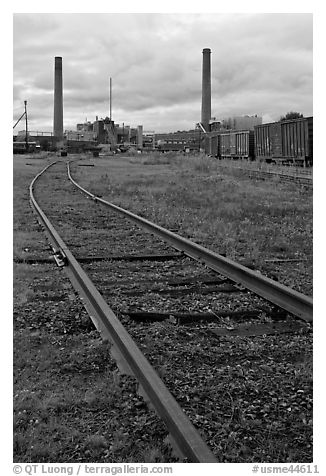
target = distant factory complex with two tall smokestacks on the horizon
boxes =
[16,52,262,156]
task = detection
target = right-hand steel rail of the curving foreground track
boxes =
[67,163,313,322]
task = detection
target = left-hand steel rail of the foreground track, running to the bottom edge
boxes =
[30,162,217,463]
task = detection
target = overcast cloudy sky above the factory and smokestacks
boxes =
[13,13,313,132]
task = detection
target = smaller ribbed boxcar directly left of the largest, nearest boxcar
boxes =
[219,131,255,160]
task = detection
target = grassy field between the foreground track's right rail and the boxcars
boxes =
[73,154,313,294]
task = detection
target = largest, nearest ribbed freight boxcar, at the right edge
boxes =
[255,117,313,166]
